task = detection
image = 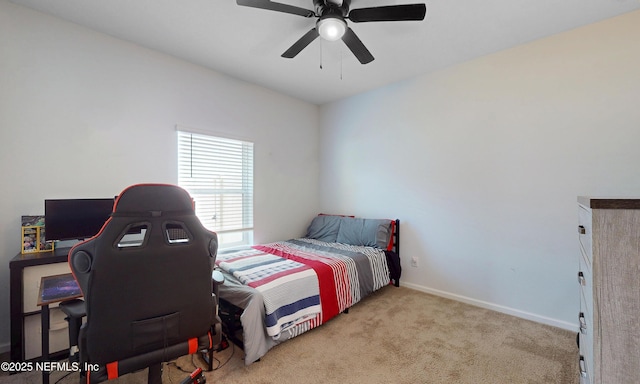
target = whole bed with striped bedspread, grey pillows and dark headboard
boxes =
[216,214,401,365]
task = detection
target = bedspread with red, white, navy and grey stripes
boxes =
[216,239,389,339]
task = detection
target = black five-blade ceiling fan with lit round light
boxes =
[236,0,427,64]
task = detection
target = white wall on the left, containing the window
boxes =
[0,0,319,351]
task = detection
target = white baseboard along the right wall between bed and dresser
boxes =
[400,282,578,332]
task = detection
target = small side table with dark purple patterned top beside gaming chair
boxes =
[38,273,82,384]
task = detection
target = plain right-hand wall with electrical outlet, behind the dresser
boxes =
[320,12,640,329]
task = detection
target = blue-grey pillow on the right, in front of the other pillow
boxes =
[336,217,391,249]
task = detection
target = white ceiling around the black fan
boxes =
[11,0,640,104]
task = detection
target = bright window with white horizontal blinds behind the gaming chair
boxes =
[178,131,253,248]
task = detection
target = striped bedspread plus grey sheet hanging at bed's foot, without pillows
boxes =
[216,238,397,365]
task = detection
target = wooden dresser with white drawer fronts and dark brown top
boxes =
[578,197,640,384]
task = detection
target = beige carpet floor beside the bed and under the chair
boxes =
[0,286,579,384]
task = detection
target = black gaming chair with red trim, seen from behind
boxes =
[69,184,221,383]
